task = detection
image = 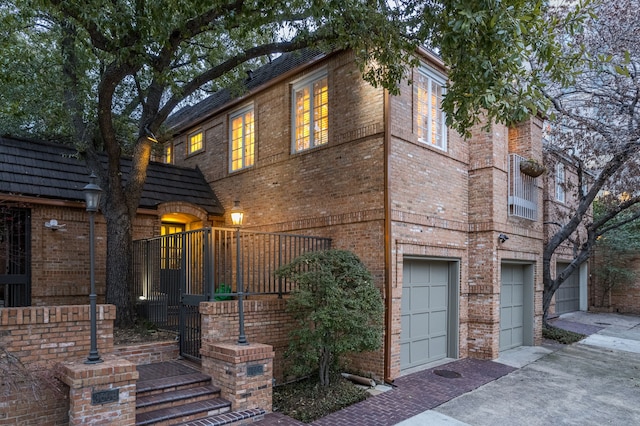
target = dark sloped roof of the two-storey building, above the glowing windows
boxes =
[166,49,325,133]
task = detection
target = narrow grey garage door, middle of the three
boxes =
[500,265,524,350]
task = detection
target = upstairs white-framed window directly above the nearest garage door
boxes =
[414,66,447,151]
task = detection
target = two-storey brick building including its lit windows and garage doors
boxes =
[165,51,544,380]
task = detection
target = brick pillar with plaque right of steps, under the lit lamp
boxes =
[200,342,274,412]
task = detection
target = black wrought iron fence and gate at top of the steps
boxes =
[133,228,331,359]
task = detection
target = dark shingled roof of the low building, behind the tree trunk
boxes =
[0,137,224,215]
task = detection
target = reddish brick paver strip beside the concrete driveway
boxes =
[255,358,516,426]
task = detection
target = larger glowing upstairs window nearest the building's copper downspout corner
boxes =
[292,69,329,152]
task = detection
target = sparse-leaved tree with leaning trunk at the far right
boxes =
[543,0,640,324]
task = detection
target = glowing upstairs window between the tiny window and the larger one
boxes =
[229,105,255,172]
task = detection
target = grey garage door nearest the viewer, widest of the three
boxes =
[400,260,449,370]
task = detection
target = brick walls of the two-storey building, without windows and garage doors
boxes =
[173,48,543,380]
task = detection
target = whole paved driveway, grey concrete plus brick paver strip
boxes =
[256,312,640,426]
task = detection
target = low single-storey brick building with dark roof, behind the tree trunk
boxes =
[0,137,223,307]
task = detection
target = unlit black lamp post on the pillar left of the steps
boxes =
[82,173,102,364]
